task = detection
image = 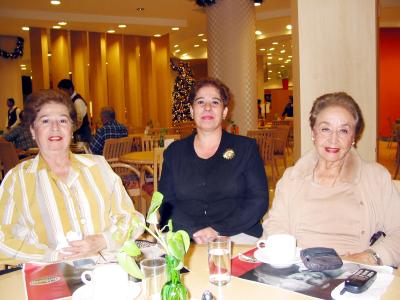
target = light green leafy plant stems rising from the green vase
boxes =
[114,192,190,279]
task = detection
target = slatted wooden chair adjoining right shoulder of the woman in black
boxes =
[247,129,278,182]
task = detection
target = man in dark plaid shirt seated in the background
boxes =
[90,106,128,155]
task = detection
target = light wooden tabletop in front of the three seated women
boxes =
[0,244,400,300]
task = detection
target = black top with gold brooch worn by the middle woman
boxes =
[159,131,268,237]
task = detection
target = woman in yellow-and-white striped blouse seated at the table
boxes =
[0,90,144,264]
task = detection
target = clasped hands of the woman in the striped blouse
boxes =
[58,234,107,260]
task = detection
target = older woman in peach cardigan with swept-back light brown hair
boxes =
[263,92,400,266]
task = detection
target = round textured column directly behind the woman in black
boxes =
[206,0,257,134]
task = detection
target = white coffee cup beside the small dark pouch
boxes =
[257,234,296,264]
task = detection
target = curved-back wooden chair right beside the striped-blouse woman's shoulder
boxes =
[110,162,147,216]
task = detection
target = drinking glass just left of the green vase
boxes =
[140,257,167,300]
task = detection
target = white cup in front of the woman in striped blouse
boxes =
[81,264,129,300]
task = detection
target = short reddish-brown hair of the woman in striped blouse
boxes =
[24,90,77,127]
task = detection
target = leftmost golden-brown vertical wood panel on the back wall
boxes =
[29,27,50,91]
